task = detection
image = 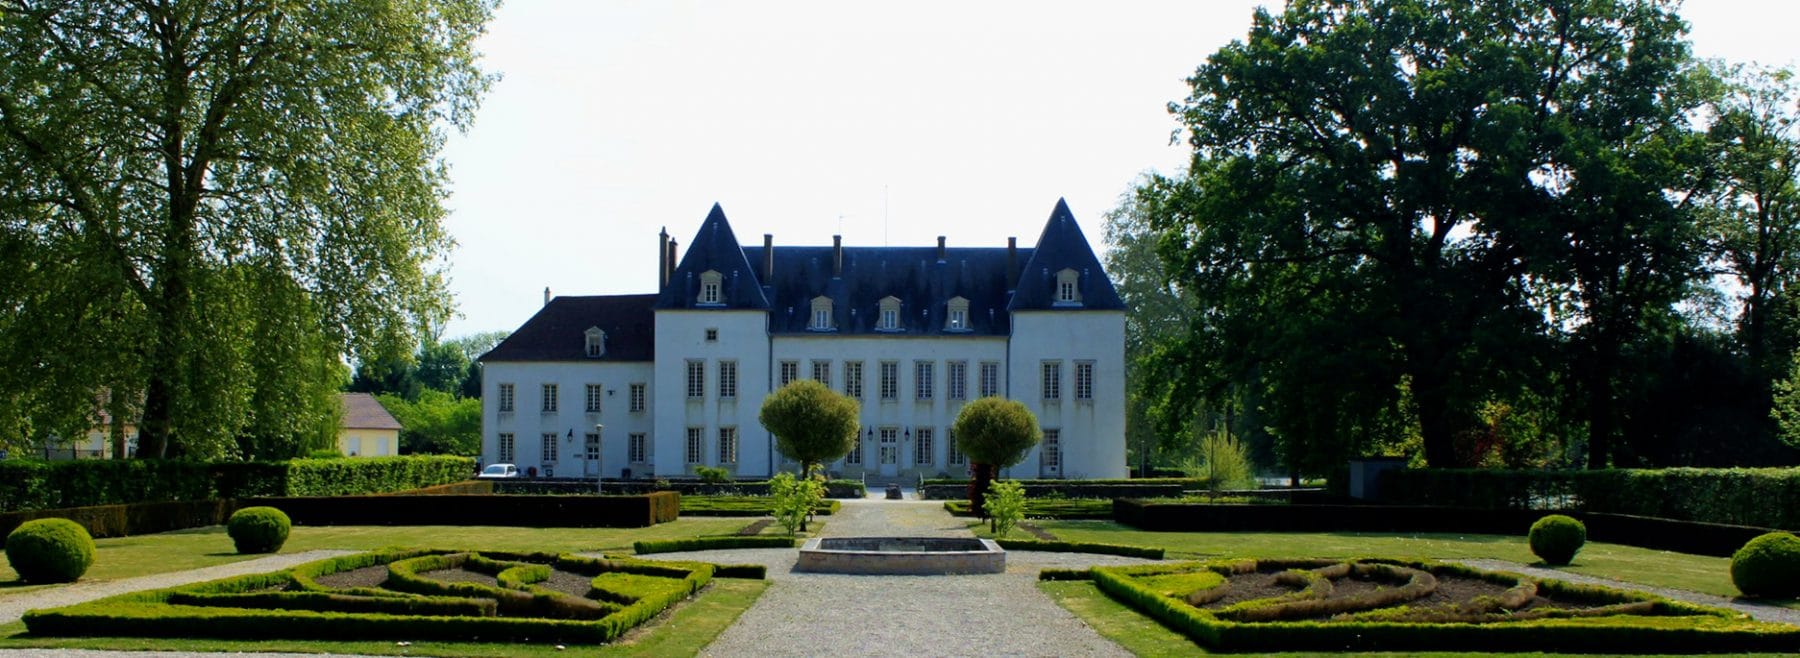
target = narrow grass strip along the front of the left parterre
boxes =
[0,579,769,656]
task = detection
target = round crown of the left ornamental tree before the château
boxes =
[756,379,862,475]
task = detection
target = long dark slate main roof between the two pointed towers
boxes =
[743,246,1031,336]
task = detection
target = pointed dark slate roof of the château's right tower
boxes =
[1008,200,1125,311]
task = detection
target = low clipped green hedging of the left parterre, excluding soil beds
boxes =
[23,550,713,644]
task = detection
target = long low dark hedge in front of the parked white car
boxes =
[243,491,680,529]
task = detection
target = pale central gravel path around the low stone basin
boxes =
[646,500,1141,656]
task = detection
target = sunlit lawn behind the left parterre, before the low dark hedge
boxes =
[0,518,754,597]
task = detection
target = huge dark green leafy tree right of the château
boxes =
[1141,0,1697,467]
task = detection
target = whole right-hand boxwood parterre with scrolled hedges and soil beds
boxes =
[1065,559,1800,653]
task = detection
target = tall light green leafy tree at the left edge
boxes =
[0,0,493,457]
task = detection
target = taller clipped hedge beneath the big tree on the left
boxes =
[0,455,475,512]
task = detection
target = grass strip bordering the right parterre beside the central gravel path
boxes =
[1037,581,1780,658]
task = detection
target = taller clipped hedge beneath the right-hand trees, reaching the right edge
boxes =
[1381,467,1800,530]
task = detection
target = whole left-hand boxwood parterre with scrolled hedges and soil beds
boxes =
[23,548,763,644]
